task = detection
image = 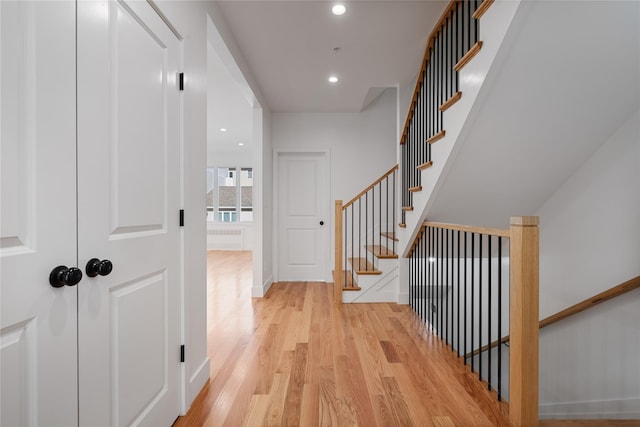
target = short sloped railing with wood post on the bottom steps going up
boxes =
[334,165,398,303]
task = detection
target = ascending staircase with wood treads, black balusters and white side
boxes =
[334,0,520,304]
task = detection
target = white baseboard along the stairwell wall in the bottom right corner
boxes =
[540,397,640,419]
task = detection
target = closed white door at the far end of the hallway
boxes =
[278,153,329,282]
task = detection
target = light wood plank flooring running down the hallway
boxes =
[174,251,509,427]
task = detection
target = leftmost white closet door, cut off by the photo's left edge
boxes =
[0,1,77,427]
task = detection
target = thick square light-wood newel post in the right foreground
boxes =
[509,216,540,427]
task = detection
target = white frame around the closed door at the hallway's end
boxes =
[272,148,333,283]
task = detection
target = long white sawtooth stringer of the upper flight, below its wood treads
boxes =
[398,0,521,258]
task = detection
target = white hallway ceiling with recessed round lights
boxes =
[212,0,448,112]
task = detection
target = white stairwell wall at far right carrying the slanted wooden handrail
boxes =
[538,111,640,418]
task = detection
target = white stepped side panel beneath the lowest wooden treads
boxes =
[342,258,400,303]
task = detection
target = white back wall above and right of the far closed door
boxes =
[272,88,398,276]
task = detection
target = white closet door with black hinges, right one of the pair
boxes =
[77,1,180,426]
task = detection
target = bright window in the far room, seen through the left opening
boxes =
[207,167,253,222]
